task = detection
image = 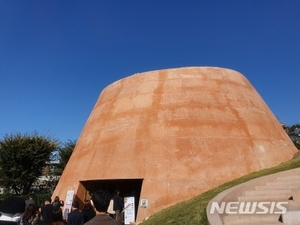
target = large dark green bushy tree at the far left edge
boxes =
[0,132,57,195]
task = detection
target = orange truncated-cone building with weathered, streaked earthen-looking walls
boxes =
[53,67,297,221]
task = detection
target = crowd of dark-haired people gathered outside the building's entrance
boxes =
[20,190,124,225]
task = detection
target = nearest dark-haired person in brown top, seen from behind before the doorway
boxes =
[84,190,120,225]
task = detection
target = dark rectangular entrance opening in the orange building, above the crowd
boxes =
[80,179,143,218]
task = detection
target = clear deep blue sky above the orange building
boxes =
[0,0,300,142]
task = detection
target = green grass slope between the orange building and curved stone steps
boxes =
[142,157,300,225]
